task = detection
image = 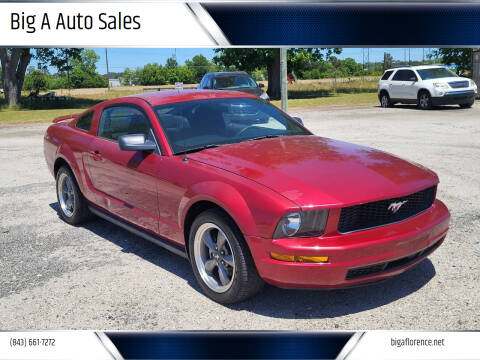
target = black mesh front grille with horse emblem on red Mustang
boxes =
[338,186,436,233]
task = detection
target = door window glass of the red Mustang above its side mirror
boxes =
[98,105,151,141]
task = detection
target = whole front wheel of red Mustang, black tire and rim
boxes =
[188,209,263,304]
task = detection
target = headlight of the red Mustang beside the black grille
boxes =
[273,209,328,239]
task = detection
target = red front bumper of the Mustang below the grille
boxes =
[247,200,450,289]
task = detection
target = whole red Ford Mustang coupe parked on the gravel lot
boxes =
[44,91,450,303]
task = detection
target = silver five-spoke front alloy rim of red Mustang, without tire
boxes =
[194,223,235,293]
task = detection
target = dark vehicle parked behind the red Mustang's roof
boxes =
[198,71,270,101]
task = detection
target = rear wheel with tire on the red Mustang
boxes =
[56,166,92,225]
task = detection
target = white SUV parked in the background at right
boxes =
[378,65,477,109]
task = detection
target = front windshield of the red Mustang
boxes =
[154,98,311,155]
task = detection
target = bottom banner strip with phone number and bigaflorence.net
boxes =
[0,331,480,360]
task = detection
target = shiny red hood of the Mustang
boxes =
[189,135,438,207]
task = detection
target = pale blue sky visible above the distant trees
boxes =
[33,48,433,74]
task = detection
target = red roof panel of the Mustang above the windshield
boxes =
[124,90,258,106]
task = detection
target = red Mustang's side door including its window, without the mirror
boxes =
[87,103,161,233]
